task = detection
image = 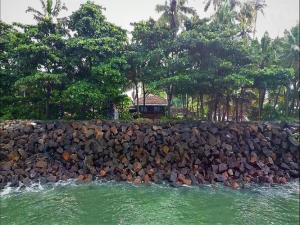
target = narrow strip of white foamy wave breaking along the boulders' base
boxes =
[0,179,300,198]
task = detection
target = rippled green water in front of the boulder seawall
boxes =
[0,182,299,225]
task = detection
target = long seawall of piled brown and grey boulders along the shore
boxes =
[0,121,299,188]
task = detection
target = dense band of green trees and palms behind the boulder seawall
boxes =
[0,0,300,121]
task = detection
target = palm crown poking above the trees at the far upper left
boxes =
[26,0,67,21]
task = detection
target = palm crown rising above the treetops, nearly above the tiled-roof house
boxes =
[156,0,197,33]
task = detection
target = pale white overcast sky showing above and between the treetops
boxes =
[0,0,299,38]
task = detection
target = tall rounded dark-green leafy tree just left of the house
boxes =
[63,1,127,118]
